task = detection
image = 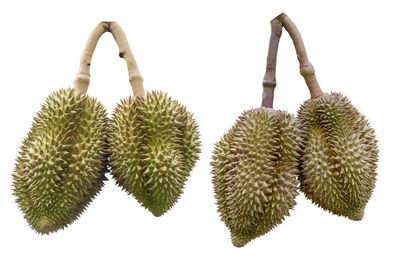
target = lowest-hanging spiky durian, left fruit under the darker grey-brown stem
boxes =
[211,108,299,247]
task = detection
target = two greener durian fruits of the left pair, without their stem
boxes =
[13,89,200,234]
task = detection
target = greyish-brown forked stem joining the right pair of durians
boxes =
[263,13,323,103]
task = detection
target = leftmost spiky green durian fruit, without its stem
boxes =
[13,89,107,234]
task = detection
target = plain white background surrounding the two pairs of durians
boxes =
[0,0,400,267]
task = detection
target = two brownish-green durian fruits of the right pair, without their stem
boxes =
[211,93,378,247]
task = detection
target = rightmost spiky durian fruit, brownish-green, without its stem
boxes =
[298,93,378,220]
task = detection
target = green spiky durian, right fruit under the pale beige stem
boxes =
[110,91,200,216]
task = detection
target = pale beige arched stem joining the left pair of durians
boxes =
[74,21,144,96]
